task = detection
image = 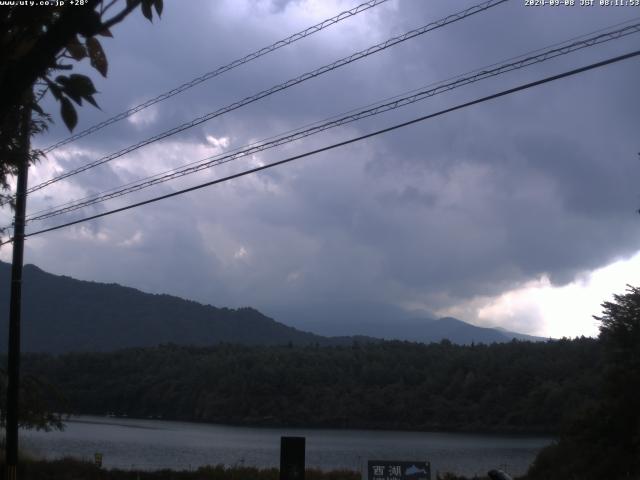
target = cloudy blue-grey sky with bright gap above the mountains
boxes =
[0,0,640,337]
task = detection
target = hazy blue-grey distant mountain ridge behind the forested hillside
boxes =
[0,262,540,353]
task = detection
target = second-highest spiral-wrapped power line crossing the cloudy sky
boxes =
[21,0,508,198]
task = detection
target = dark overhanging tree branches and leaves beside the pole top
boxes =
[0,0,163,218]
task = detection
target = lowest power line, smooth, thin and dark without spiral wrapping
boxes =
[0,50,640,245]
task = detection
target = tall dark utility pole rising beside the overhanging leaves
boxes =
[6,94,32,480]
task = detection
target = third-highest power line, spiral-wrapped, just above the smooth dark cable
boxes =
[23,23,640,222]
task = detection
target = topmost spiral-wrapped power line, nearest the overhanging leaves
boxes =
[42,0,387,153]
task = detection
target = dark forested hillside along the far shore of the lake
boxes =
[23,339,600,432]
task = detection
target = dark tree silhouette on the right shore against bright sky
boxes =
[527,286,640,480]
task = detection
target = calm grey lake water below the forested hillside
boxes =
[20,416,552,478]
